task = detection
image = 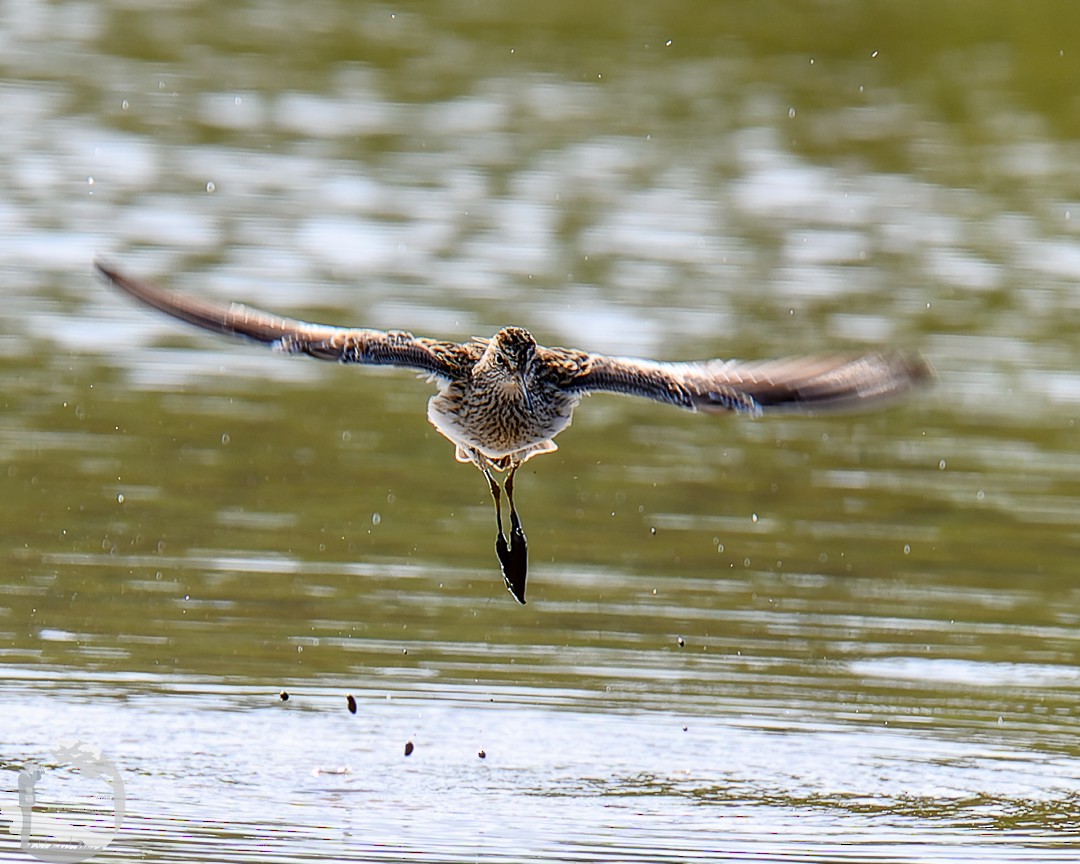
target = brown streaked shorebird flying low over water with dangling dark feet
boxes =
[95,261,932,604]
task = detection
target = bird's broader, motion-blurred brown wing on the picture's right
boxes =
[548,349,933,415]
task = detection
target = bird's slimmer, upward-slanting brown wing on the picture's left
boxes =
[94,261,470,379]
